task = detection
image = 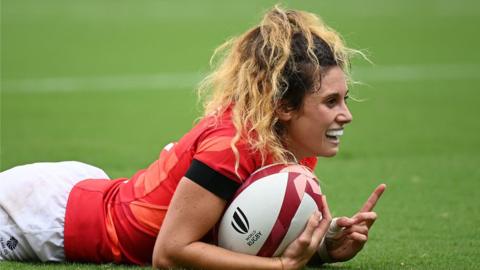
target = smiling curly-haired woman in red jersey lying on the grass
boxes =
[0,7,385,269]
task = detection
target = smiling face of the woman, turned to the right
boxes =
[279,66,352,160]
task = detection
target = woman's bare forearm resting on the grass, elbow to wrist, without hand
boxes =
[154,242,283,270]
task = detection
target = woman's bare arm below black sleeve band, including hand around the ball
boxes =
[153,177,329,269]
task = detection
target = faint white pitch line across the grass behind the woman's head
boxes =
[1,64,480,92]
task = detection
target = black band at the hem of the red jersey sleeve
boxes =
[185,159,240,201]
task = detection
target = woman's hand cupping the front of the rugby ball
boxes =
[280,196,332,270]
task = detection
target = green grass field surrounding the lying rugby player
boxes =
[0,0,480,270]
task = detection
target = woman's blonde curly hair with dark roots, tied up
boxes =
[198,6,359,168]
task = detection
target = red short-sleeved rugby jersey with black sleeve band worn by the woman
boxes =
[64,107,317,264]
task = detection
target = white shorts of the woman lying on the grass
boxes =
[0,161,109,261]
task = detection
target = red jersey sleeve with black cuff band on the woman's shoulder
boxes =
[185,128,257,201]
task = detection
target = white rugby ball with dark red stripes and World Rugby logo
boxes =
[218,164,322,257]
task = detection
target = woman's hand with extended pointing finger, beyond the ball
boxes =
[325,184,387,261]
